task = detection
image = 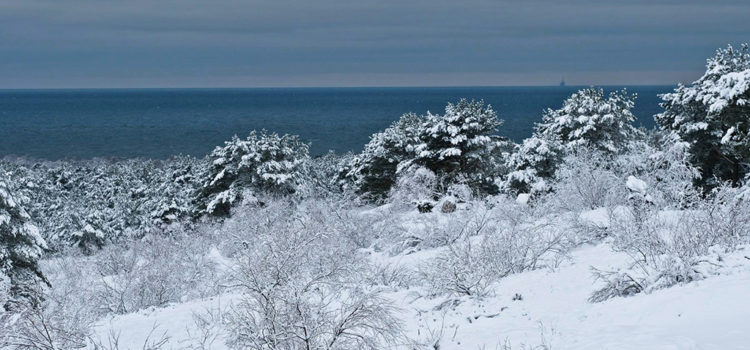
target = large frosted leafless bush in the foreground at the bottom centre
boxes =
[222,202,401,349]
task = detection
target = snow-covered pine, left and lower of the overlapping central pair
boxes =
[346,113,424,201]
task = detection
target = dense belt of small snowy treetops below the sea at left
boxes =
[0,157,200,252]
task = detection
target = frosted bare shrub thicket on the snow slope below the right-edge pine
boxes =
[591,185,750,301]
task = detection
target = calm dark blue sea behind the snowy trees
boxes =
[0,86,673,160]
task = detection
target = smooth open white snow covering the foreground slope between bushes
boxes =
[89,238,750,350]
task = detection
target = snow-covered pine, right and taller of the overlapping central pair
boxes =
[414,99,506,194]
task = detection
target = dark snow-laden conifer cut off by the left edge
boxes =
[0,179,48,310]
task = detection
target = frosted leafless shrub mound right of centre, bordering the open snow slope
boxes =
[420,204,570,297]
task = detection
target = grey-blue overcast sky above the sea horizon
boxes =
[0,0,750,88]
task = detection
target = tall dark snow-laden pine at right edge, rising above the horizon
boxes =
[655,44,750,188]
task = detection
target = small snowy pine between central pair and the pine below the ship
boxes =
[503,135,563,195]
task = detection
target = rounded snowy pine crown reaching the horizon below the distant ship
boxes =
[537,88,637,154]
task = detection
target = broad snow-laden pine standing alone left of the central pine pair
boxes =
[196,130,310,216]
